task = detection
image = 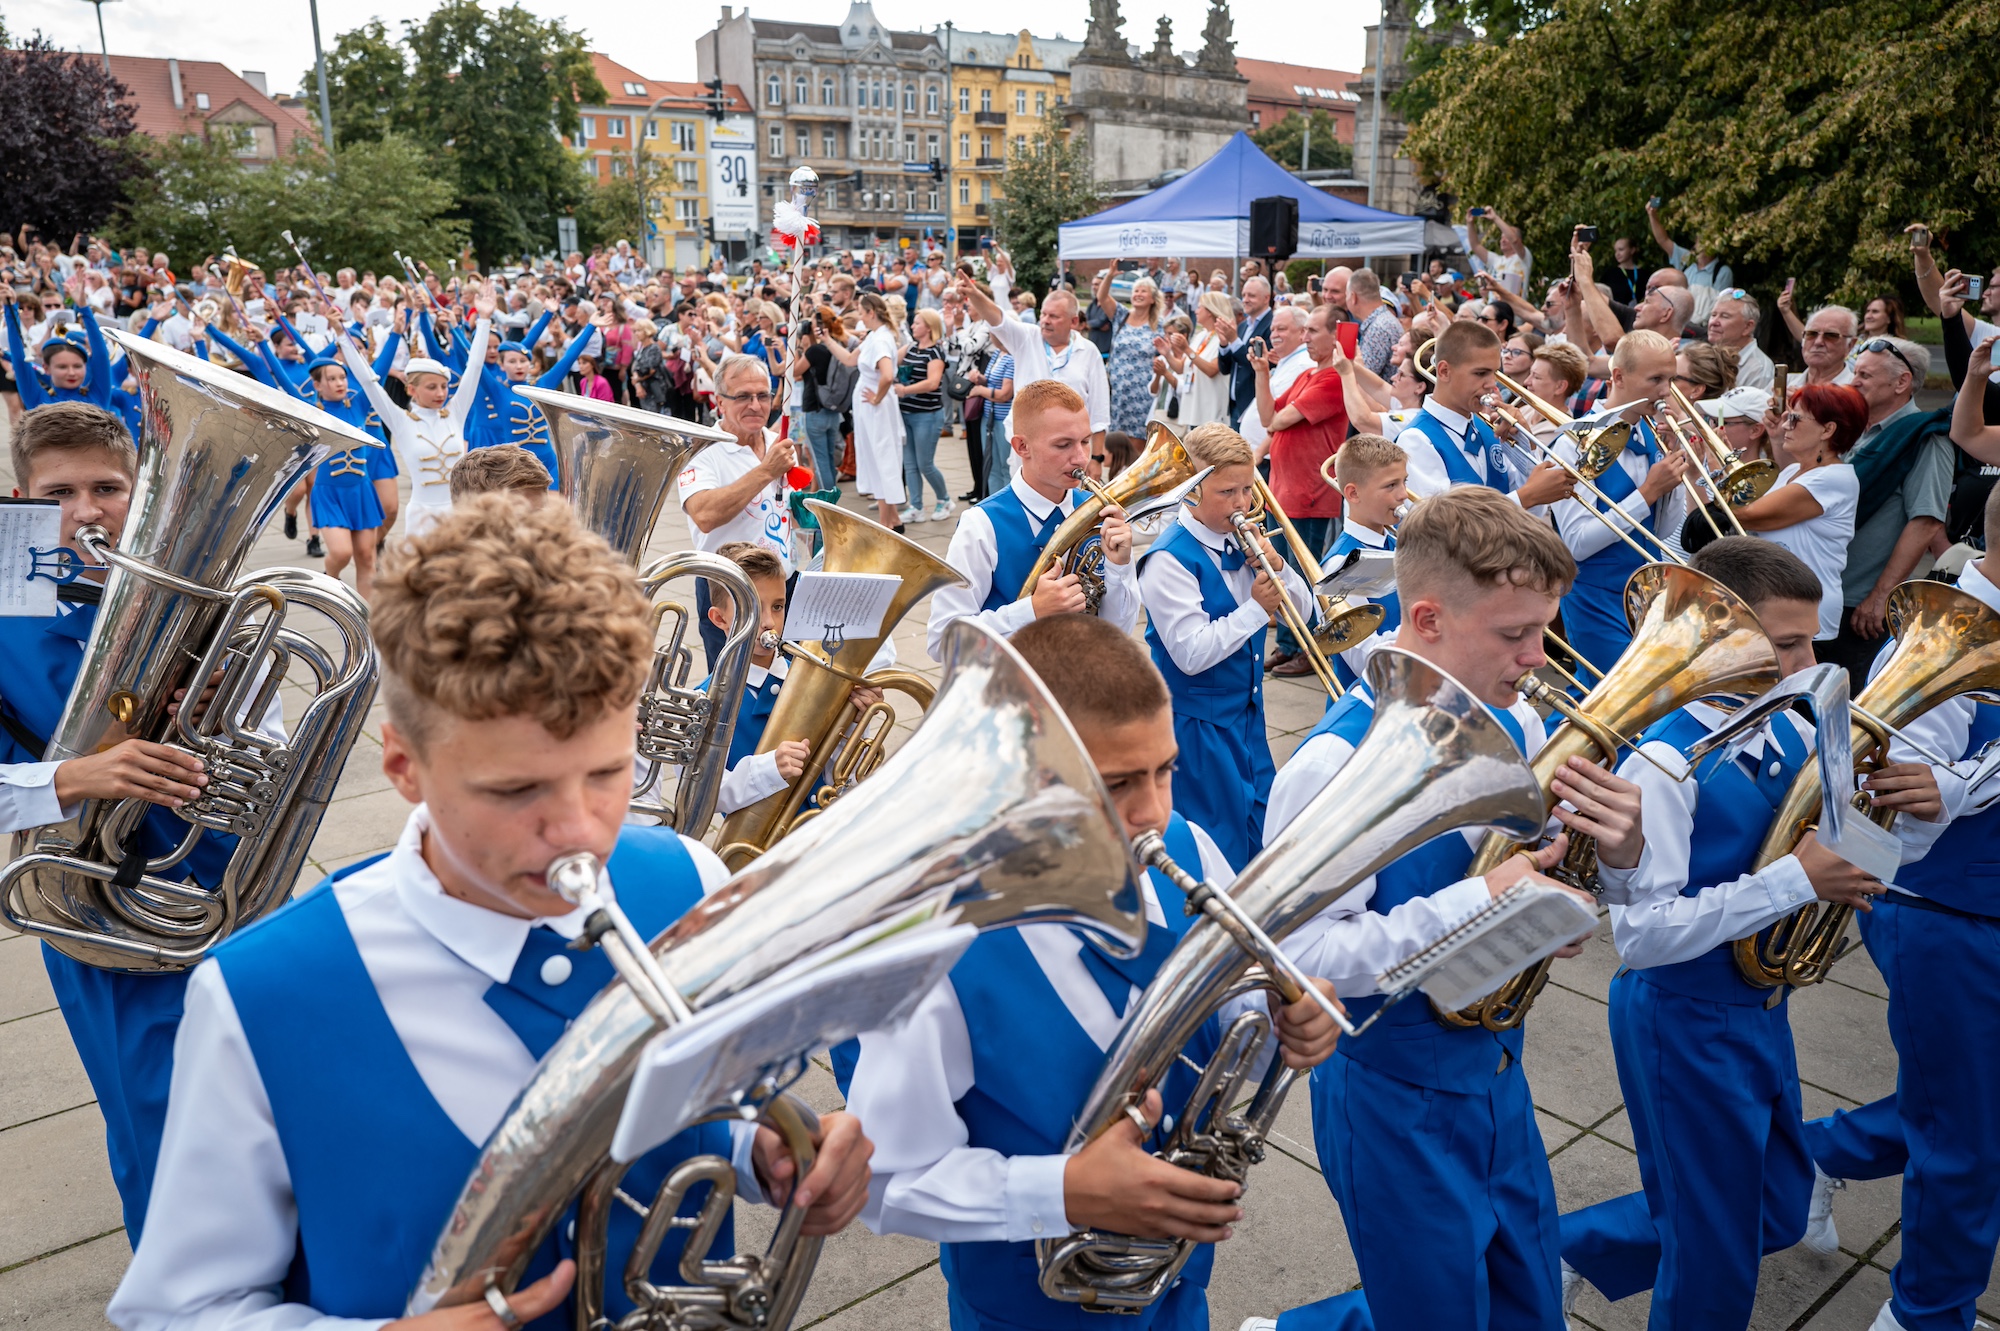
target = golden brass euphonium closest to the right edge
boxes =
[1736,578,2000,989]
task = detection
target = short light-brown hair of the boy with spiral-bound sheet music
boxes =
[1400,481,1576,606]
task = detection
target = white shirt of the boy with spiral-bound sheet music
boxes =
[1264,683,1644,997]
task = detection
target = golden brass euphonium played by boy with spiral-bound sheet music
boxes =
[1438,564,1778,1031]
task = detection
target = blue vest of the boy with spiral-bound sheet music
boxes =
[1306,689,1524,1093]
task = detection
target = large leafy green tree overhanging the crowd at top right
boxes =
[1408,0,2000,304]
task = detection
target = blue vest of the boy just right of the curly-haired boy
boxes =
[940,813,1218,1331]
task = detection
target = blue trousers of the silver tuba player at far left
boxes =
[42,943,192,1247]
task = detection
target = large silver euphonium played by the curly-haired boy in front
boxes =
[410,622,1146,1331]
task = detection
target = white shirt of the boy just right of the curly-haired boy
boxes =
[848,823,1264,1243]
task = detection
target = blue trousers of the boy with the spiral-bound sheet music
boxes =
[1312,1051,1562,1331]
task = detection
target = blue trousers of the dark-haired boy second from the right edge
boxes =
[1562,971,1812,1331]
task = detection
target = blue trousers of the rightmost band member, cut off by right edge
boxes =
[1806,893,2000,1331]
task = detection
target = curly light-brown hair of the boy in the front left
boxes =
[368,494,652,751]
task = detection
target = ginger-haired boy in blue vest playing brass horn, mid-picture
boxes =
[930,380,1140,660]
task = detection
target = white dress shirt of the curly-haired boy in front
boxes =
[106,805,762,1331]
